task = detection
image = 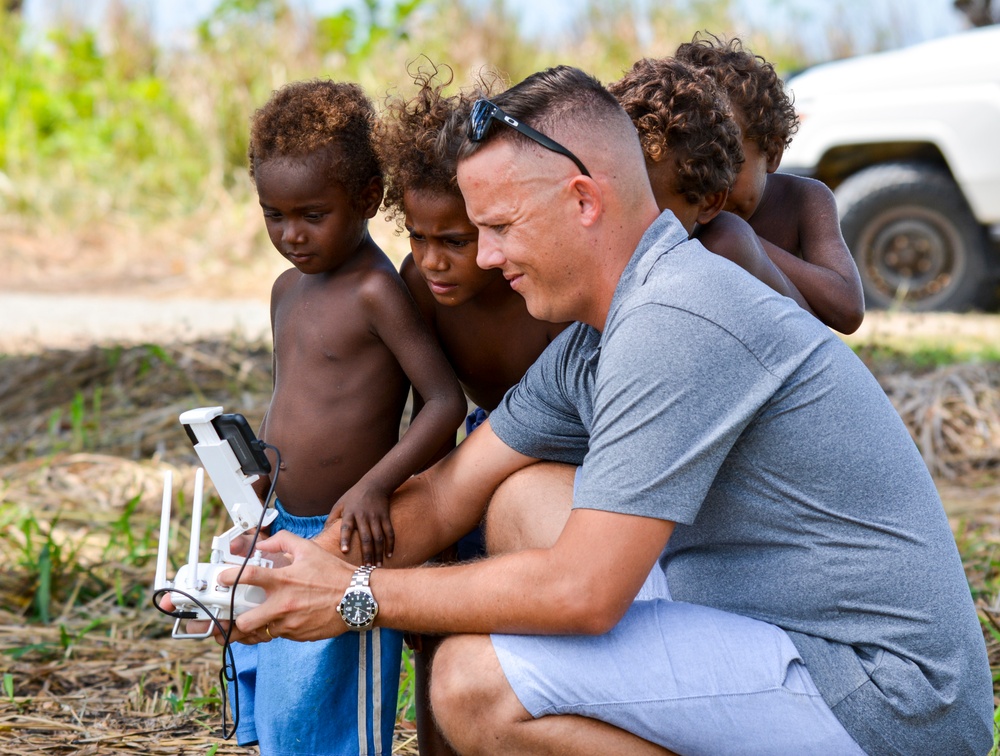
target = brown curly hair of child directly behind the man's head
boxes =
[608,58,744,204]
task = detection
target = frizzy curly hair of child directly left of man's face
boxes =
[379,63,496,230]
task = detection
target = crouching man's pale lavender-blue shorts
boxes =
[491,596,864,756]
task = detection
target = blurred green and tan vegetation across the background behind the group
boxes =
[0,0,928,297]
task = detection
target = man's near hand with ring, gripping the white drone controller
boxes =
[219,531,354,644]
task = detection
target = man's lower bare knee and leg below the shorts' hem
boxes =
[431,635,671,756]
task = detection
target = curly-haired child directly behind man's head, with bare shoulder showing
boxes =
[608,58,811,311]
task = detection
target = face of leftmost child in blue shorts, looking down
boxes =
[255,157,381,274]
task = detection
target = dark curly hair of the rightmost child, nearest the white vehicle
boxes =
[677,34,799,160]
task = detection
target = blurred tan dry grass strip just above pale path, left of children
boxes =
[0,207,409,306]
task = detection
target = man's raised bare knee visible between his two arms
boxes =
[485,462,576,554]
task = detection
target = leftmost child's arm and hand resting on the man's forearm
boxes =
[330,274,466,564]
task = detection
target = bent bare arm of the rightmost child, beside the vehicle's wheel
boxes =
[761,181,865,333]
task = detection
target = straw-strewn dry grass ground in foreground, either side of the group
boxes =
[0,341,1000,754]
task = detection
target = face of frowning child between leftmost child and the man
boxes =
[403,190,501,307]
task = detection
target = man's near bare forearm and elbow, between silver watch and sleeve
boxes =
[371,510,673,635]
